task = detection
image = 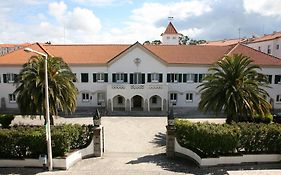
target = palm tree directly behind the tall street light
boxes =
[15,56,78,124]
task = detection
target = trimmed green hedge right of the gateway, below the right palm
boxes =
[175,120,281,157]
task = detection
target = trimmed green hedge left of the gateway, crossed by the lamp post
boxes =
[0,124,93,158]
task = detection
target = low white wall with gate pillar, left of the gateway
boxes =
[0,127,103,170]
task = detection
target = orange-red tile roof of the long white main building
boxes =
[0,43,281,66]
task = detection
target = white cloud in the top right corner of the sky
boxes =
[243,0,281,17]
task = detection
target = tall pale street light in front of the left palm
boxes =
[24,48,53,171]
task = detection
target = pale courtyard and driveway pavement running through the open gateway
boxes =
[0,117,281,175]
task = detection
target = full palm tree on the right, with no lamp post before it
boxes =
[198,54,271,123]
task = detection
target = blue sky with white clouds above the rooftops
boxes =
[0,0,281,44]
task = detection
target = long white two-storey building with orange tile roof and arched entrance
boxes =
[0,22,281,115]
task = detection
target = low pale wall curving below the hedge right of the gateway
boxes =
[175,139,281,166]
